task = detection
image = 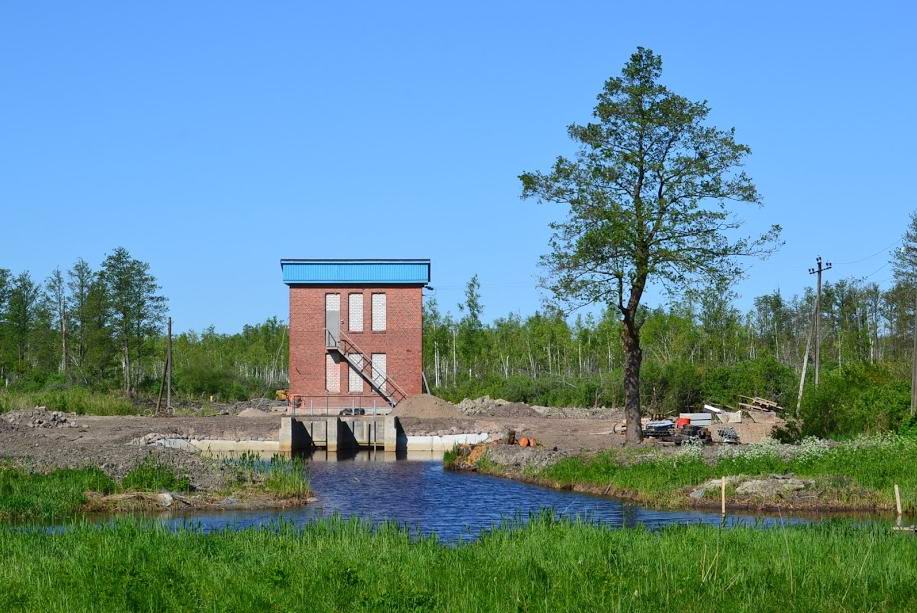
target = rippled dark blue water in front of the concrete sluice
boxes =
[163,455,799,542]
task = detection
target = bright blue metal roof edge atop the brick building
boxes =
[280,259,430,285]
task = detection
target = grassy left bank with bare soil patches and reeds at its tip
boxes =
[0,456,310,523]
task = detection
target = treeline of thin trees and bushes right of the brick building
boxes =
[424,277,914,434]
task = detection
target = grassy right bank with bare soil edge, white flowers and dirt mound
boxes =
[445,435,917,512]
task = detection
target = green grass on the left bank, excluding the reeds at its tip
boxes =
[0,457,191,520]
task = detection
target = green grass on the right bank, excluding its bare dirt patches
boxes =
[532,435,917,512]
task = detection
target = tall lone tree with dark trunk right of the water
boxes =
[520,48,780,443]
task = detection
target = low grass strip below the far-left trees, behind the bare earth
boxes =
[0,387,140,415]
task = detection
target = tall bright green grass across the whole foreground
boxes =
[0,516,917,612]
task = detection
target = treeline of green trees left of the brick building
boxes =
[0,248,287,400]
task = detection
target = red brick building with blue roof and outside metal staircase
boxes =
[280,259,430,410]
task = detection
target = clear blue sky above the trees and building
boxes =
[0,0,917,332]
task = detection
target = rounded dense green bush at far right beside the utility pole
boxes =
[800,364,911,436]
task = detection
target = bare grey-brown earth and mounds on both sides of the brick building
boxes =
[0,395,774,489]
